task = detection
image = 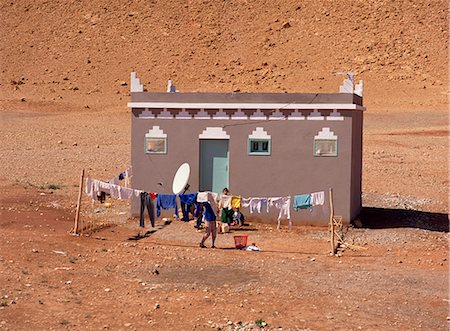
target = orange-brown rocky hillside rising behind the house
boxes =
[0,0,448,110]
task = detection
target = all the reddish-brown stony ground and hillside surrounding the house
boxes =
[0,0,450,330]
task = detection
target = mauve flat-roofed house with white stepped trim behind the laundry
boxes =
[128,73,365,225]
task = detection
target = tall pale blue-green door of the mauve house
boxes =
[200,139,229,193]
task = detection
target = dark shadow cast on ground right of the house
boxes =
[360,207,449,232]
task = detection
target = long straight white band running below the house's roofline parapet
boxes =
[128,101,366,110]
